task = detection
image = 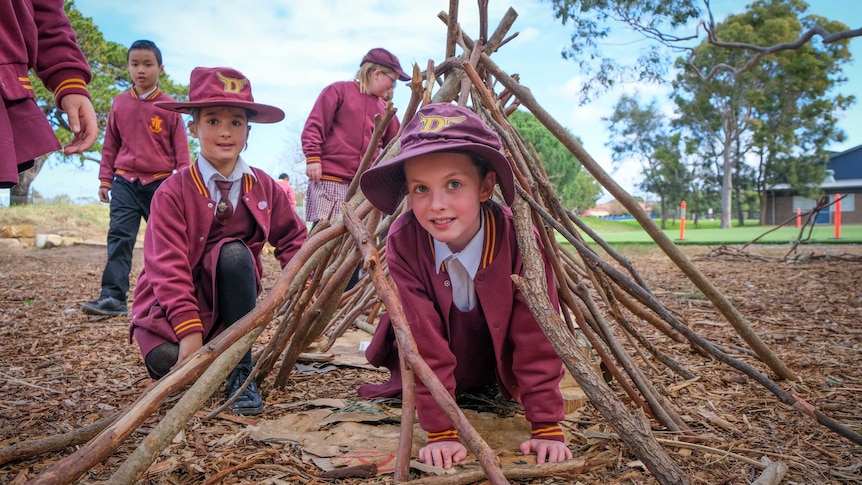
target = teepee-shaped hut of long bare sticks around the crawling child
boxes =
[8,0,862,484]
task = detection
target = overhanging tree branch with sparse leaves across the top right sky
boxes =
[551,0,862,101]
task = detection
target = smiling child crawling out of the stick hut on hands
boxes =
[359,104,572,468]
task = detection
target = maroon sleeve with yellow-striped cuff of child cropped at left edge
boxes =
[33,0,92,106]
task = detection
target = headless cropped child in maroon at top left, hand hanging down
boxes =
[0,0,99,189]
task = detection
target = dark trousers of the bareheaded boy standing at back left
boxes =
[101,175,164,302]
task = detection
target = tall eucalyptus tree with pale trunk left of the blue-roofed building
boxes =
[674,0,853,228]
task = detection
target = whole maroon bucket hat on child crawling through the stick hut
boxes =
[359,103,515,214]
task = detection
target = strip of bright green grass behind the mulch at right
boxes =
[572,217,862,246]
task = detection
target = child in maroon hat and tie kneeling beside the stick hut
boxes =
[130,67,306,415]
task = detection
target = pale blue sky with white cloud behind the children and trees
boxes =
[20,0,862,200]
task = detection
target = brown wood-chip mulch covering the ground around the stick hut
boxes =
[0,240,862,484]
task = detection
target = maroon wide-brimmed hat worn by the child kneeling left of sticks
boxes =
[156,67,284,123]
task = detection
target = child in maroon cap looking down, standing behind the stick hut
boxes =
[301,48,410,223]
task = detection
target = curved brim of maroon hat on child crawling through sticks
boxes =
[359,137,515,214]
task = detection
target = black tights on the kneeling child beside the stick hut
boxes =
[144,241,257,379]
